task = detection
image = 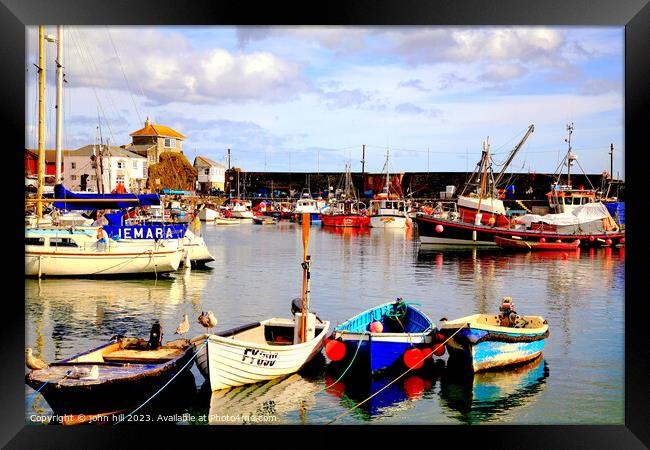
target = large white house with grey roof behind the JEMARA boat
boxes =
[63,145,147,193]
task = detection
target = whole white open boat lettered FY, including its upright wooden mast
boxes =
[191,212,330,391]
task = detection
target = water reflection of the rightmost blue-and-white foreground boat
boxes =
[440,358,549,424]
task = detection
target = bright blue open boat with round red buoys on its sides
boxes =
[325,298,444,373]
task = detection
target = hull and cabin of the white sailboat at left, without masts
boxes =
[25,227,183,277]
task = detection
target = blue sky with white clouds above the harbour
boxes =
[25,26,625,178]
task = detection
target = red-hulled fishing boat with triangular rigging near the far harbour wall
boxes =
[321,164,370,227]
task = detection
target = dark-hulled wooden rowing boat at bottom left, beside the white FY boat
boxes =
[25,336,193,416]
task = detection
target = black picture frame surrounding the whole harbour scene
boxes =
[0,0,650,449]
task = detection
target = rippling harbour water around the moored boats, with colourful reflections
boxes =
[25,222,625,425]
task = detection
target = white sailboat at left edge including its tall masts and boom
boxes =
[25,25,183,278]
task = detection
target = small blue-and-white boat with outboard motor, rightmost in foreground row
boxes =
[440,297,549,372]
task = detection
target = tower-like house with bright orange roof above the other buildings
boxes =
[122,117,187,164]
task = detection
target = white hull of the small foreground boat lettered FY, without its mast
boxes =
[194,319,329,391]
